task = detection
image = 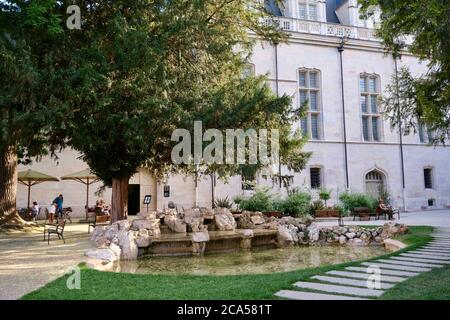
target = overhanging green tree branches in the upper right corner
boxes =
[360,0,450,143]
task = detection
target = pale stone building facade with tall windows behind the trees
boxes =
[18,0,450,218]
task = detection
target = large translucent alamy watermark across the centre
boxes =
[171,121,280,165]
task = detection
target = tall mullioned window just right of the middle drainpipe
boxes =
[359,74,381,141]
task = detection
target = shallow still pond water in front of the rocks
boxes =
[115,246,386,275]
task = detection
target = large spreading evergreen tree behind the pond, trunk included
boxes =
[63,0,310,221]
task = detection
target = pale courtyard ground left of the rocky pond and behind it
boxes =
[0,210,450,299]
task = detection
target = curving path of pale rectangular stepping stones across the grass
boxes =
[275,228,450,300]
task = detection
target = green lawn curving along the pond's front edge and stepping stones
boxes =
[22,227,436,300]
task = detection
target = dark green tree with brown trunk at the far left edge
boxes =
[0,0,64,226]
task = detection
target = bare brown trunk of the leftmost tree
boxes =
[0,146,27,227]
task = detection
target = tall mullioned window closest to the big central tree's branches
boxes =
[298,69,322,140]
